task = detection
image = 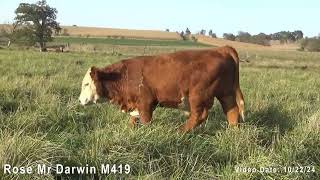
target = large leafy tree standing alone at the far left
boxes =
[15,0,61,51]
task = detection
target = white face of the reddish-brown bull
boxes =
[79,68,99,105]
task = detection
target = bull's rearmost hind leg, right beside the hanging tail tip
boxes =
[218,96,239,126]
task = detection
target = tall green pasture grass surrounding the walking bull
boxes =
[0,40,320,179]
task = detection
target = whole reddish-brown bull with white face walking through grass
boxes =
[79,46,244,132]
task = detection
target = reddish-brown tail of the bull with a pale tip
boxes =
[227,46,244,121]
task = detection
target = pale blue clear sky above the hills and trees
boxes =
[0,0,320,37]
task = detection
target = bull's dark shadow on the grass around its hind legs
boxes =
[190,105,295,146]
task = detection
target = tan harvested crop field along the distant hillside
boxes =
[0,24,298,50]
